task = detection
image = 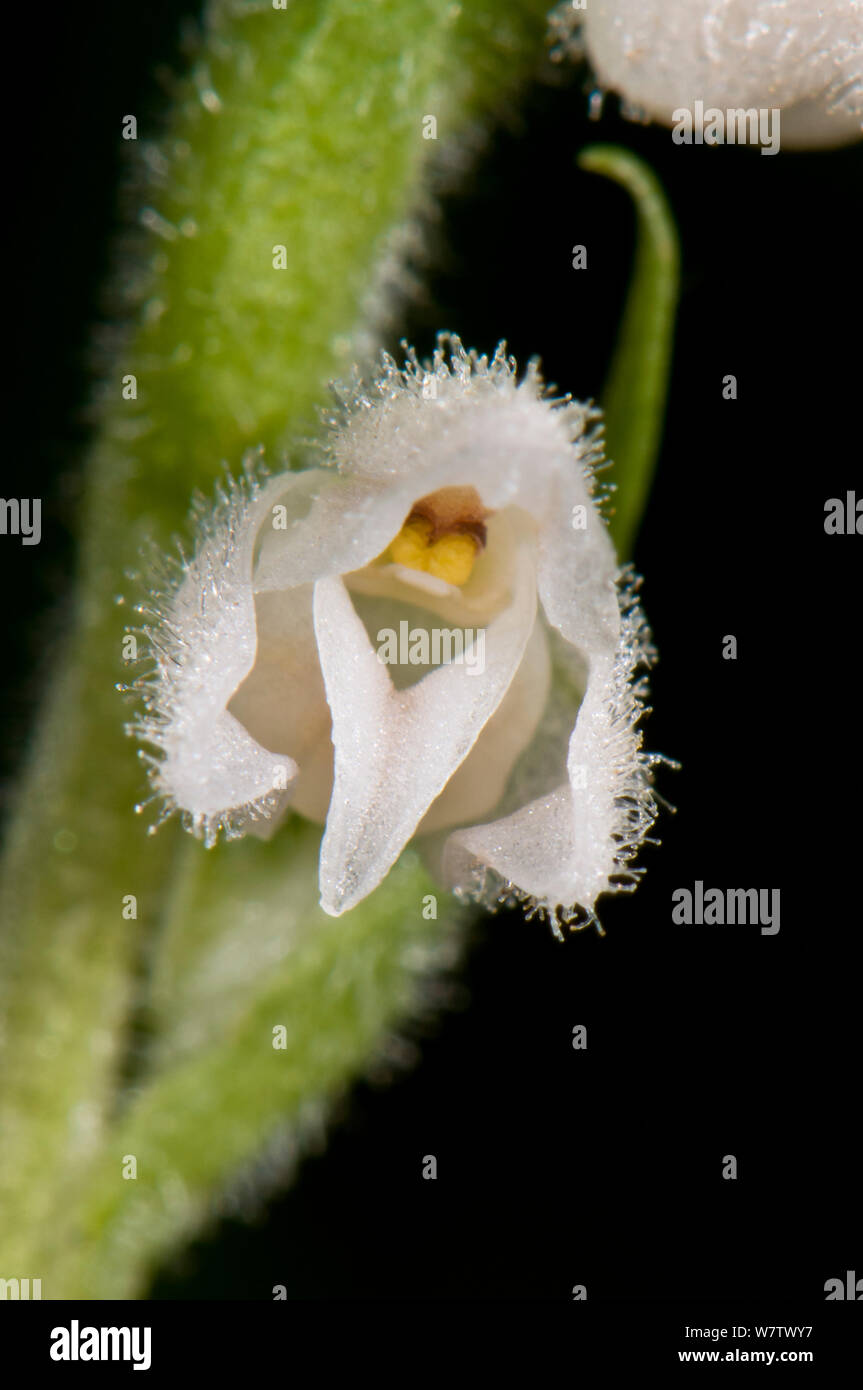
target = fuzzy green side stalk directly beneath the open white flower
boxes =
[51,826,461,1298]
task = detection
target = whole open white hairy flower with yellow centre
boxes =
[136,338,656,930]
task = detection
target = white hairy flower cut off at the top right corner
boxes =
[552,0,863,149]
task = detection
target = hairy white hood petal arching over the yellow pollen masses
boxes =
[254,360,600,592]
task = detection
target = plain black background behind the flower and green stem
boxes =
[0,0,863,1301]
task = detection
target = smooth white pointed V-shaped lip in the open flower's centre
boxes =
[314,545,536,916]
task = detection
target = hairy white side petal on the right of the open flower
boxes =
[436,405,653,920]
